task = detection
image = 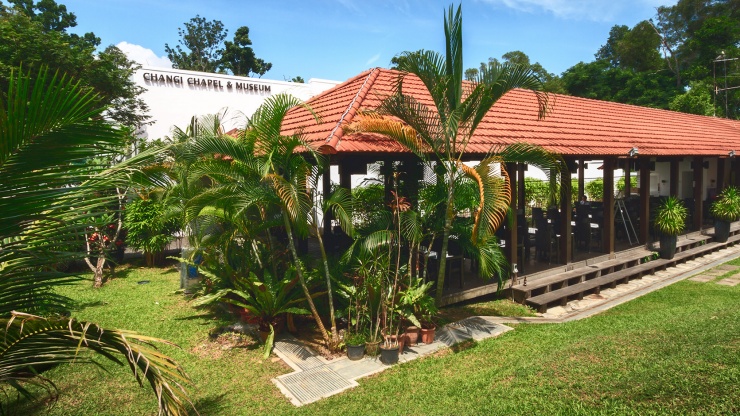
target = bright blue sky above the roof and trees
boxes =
[57,0,675,81]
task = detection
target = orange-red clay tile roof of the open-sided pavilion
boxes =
[283,68,740,156]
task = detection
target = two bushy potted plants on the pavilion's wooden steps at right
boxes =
[655,186,740,259]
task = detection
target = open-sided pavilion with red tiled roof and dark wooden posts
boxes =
[283,68,740,308]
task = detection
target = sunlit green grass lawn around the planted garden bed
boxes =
[7,260,740,415]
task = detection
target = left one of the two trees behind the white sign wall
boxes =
[164,15,229,72]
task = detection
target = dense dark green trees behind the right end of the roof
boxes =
[562,0,740,118]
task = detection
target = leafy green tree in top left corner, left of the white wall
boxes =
[0,0,149,127]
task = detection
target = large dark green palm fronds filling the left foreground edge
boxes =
[0,70,187,415]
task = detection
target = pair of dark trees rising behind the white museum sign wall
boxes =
[164,15,272,77]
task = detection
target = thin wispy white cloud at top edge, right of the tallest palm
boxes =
[481,0,656,22]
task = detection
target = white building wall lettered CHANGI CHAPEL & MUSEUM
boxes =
[134,67,339,140]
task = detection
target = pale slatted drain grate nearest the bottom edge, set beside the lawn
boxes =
[275,366,357,406]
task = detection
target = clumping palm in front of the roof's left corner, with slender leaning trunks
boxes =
[182,94,350,350]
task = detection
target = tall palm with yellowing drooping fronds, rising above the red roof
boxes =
[346,6,561,301]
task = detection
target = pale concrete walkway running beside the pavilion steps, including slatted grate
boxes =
[272,245,740,406]
